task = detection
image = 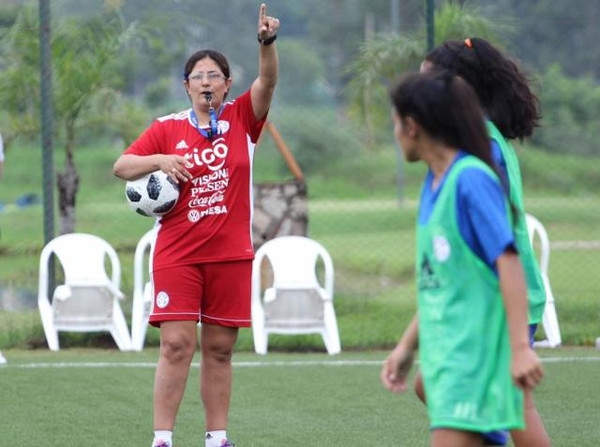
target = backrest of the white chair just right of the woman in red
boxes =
[253,236,334,299]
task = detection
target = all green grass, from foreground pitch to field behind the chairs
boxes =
[0,140,600,447]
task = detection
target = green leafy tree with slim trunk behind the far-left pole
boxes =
[0,7,143,233]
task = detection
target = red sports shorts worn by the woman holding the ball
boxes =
[150,260,252,327]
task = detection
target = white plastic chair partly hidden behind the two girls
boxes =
[525,214,562,348]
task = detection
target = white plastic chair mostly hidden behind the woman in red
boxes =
[131,228,157,351]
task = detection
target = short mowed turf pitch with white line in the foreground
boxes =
[0,350,600,447]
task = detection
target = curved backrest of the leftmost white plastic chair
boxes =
[40,233,121,289]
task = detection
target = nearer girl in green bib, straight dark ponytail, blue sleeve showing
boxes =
[381,72,543,447]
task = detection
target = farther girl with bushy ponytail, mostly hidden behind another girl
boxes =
[415,38,550,447]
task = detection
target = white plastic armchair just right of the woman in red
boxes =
[252,236,341,355]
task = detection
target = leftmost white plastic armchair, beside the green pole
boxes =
[38,233,131,351]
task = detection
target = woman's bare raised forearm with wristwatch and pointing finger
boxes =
[250,3,279,119]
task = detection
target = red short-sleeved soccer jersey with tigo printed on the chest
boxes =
[125,91,266,269]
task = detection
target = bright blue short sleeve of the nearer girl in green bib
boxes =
[456,168,515,271]
